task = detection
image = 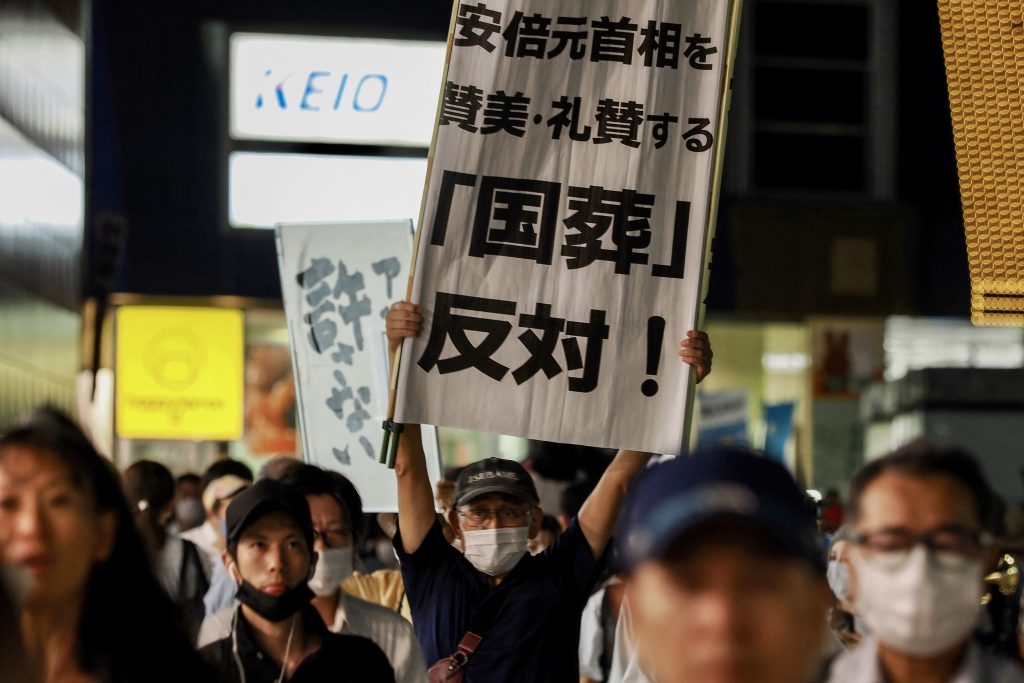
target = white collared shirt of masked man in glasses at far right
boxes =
[827,637,1024,683]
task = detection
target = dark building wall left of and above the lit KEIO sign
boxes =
[96,0,451,299]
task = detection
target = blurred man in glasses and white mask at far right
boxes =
[828,441,1024,683]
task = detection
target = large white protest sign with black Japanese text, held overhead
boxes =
[396,0,733,453]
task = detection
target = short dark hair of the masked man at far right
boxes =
[849,439,996,530]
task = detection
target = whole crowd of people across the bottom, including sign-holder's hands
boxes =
[0,304,1024,683]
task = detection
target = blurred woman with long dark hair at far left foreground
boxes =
[0,411,216,683]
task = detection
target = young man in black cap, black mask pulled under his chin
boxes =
[200,479,394,683]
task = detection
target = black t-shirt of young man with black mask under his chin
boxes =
[200,606,394,683]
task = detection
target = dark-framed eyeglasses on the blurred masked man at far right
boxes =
[850,526,987,568]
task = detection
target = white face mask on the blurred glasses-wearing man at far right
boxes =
[850,545,984,657]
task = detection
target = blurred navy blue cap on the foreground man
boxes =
[615,446,823,571]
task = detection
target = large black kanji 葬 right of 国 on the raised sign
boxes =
[562,186,654,274]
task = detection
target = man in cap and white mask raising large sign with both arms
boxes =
[387,303,712,683]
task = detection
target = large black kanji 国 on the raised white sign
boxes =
[469,176,562,265]
